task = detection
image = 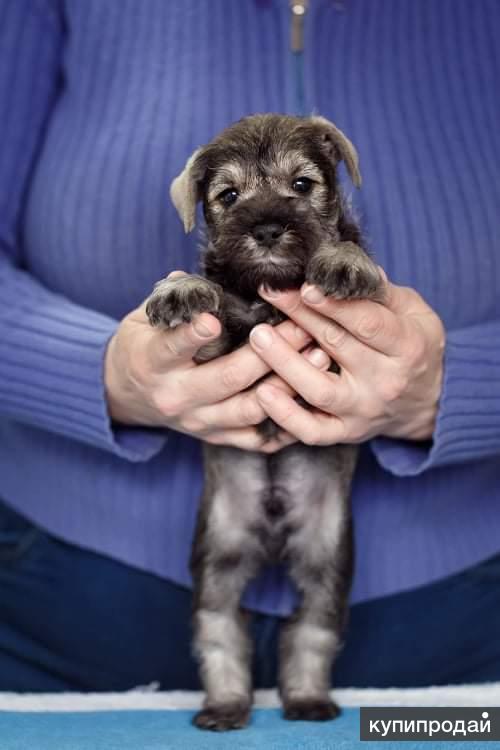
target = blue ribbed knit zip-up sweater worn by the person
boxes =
[0,0,500,613]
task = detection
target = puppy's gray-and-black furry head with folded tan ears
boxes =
[171,115,361,298]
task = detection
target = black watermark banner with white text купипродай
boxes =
[359,707,500,742]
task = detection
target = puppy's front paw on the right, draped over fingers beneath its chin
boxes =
[306,243,382,299]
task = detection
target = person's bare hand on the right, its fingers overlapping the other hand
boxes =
[250,269,445,445]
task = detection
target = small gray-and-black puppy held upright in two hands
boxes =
[147,115,380,730]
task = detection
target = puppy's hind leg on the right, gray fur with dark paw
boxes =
[272,444,357,720]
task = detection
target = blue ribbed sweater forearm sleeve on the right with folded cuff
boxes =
[371,321,500,476]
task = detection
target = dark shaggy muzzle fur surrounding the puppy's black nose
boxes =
[204,210,324,299]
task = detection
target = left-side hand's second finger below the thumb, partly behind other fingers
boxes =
[191,348,330,428]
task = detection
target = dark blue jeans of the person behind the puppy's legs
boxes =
[0,503,500,691]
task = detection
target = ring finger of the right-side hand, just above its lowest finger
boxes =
[250,324,354,414]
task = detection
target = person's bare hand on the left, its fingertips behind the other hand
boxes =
[104,303,330,453]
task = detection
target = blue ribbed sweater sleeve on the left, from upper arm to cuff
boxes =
[0,0,167,461]
